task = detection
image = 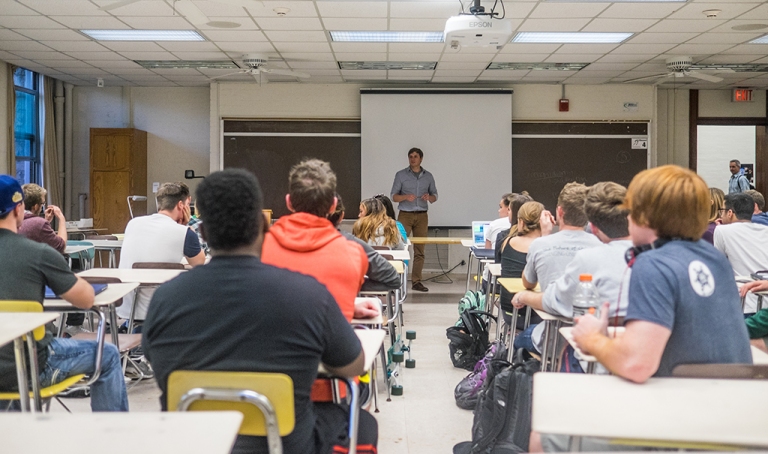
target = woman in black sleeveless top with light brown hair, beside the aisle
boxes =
[500,202,544,326]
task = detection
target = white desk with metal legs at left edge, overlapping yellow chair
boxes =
[0,312,59,412]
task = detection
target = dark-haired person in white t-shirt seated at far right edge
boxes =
[714,193,768,314]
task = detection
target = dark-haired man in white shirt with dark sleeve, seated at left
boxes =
[117,182,205,320]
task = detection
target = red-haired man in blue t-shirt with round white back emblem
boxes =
[530,165,752,451]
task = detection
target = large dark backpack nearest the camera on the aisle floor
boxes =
[453,358,541,454]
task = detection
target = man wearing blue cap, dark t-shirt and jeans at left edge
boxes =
[0,175,128,411]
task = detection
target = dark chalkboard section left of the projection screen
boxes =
[224,121,361,218]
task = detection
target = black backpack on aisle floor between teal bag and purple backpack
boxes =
[445,310,496,371]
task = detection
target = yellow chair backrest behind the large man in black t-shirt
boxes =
[167,370,295,437]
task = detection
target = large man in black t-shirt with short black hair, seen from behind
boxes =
[143,169,378,454]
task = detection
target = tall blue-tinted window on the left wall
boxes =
[13,68,42,184]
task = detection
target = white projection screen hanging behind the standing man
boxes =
[360,89,512,227]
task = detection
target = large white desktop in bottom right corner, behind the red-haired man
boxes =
[531,373,768,450]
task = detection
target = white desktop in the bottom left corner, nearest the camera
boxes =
[0,411,243,454]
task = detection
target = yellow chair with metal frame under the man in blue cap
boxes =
[0,301,104,412]
